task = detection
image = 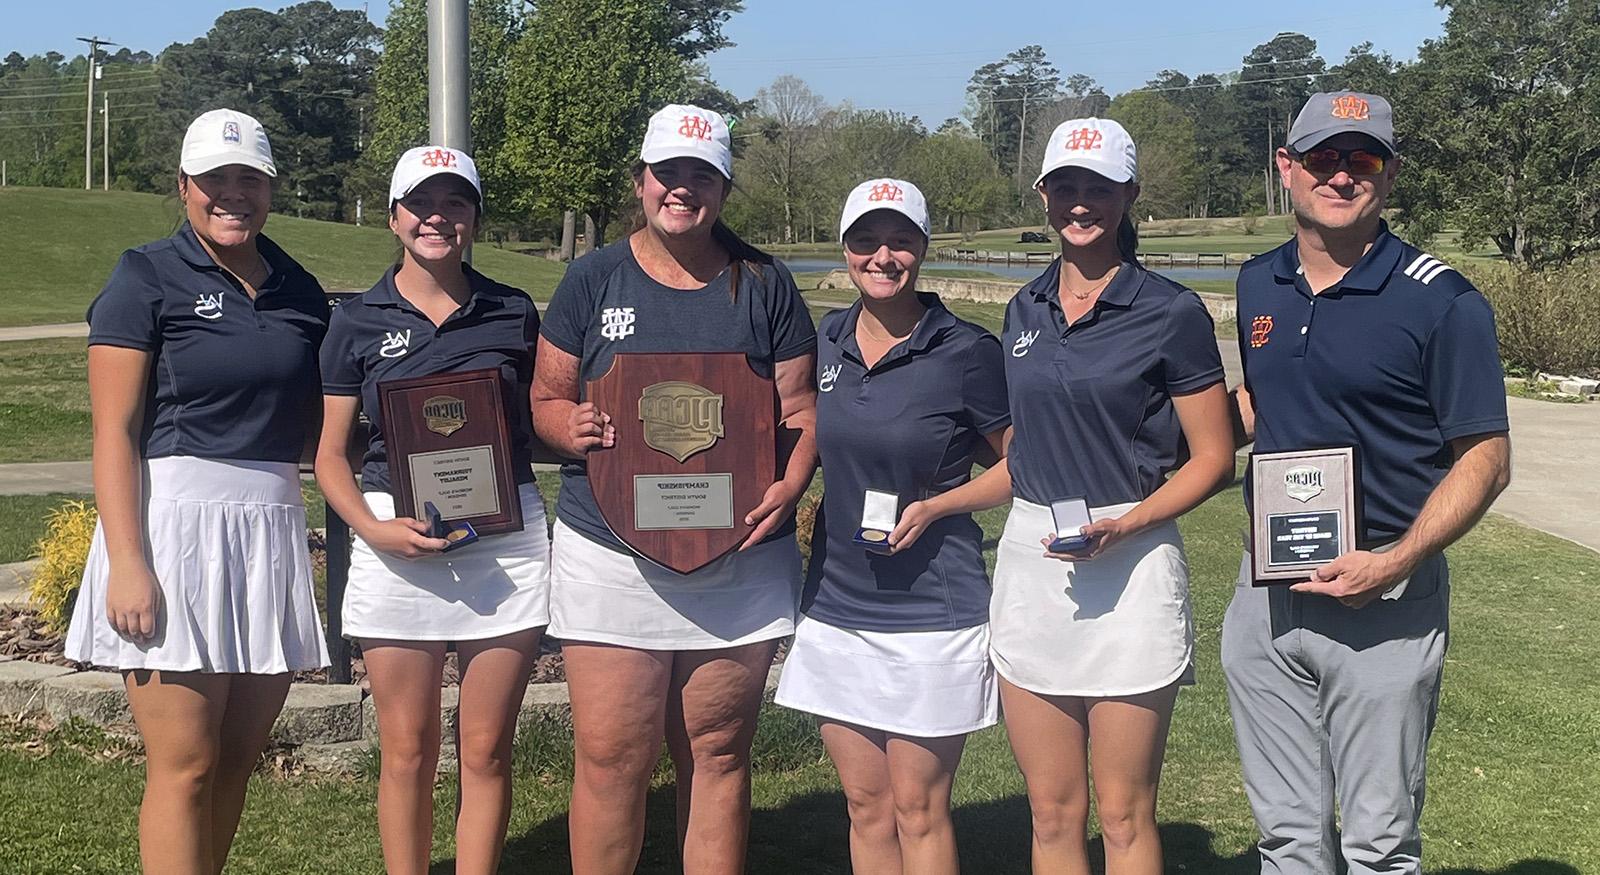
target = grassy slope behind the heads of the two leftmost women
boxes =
[0,187,565,325]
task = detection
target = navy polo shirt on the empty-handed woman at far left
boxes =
[88,222,328,462]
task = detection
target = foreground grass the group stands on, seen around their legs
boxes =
[0,489,1600,875]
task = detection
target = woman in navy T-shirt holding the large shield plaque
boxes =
[533,106,816,873]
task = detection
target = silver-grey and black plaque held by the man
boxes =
[1250,446,1357,585]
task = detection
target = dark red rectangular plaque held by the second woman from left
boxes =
[378,368,522,534]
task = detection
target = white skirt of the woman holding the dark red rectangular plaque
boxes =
[341,483,550,641]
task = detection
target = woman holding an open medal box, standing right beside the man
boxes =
[990,118,1234,875]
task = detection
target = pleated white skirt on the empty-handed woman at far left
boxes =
[66,456,328,675]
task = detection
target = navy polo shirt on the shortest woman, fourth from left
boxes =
[802,294,1011,632]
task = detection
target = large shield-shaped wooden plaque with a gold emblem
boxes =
[587,352,778,574]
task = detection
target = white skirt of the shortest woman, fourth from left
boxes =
[776,617,1000,737]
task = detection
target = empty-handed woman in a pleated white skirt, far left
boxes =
[66,109,328,875]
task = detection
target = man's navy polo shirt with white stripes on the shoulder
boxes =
[1238,224,1509,545]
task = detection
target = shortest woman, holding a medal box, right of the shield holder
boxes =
[778,179,1011,875]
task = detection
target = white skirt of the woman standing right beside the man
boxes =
[989,499,1195,697]
